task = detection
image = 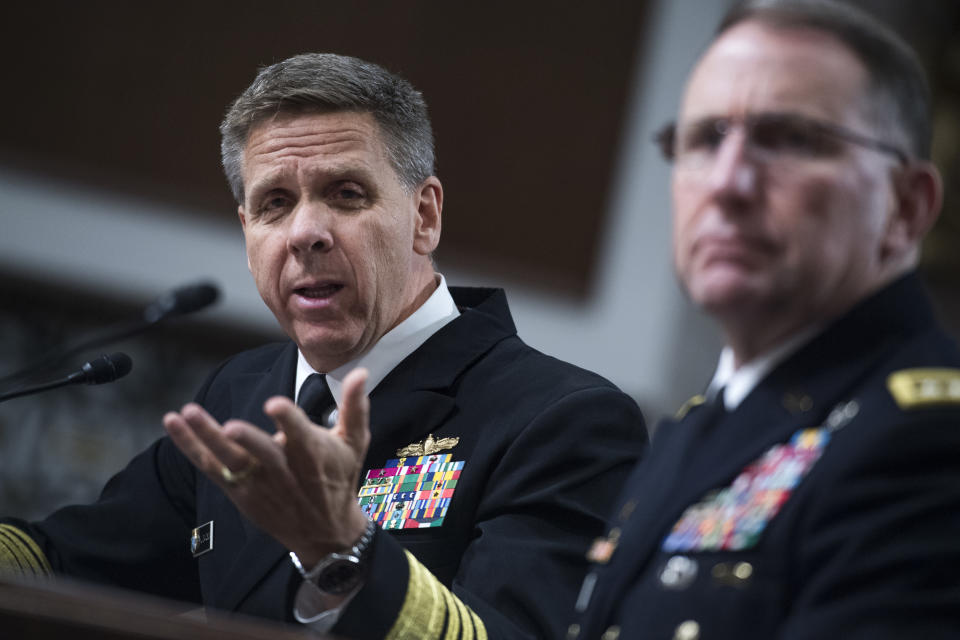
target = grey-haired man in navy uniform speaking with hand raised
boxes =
[0,54,646,639]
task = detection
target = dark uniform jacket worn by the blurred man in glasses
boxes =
[568,275,960,640]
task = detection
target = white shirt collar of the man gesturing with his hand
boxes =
[294,273,460,405]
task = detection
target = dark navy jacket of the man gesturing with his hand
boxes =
[0,288,646,638]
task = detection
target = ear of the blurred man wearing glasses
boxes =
[883,162,943,258]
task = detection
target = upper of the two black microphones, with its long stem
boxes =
[0,282,220,384]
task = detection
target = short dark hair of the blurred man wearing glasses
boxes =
[716,0,932,160]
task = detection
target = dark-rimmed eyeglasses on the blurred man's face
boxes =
[654,113,910,169]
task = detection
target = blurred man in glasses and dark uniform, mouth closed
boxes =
[567,2,960,640]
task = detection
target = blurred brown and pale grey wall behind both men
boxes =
[0,0,960,517]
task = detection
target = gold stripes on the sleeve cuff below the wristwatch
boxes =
[386,551,487,640]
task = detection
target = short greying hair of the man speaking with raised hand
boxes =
[220,53,434,204]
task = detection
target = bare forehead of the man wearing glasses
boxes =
[681,20,868,123]
